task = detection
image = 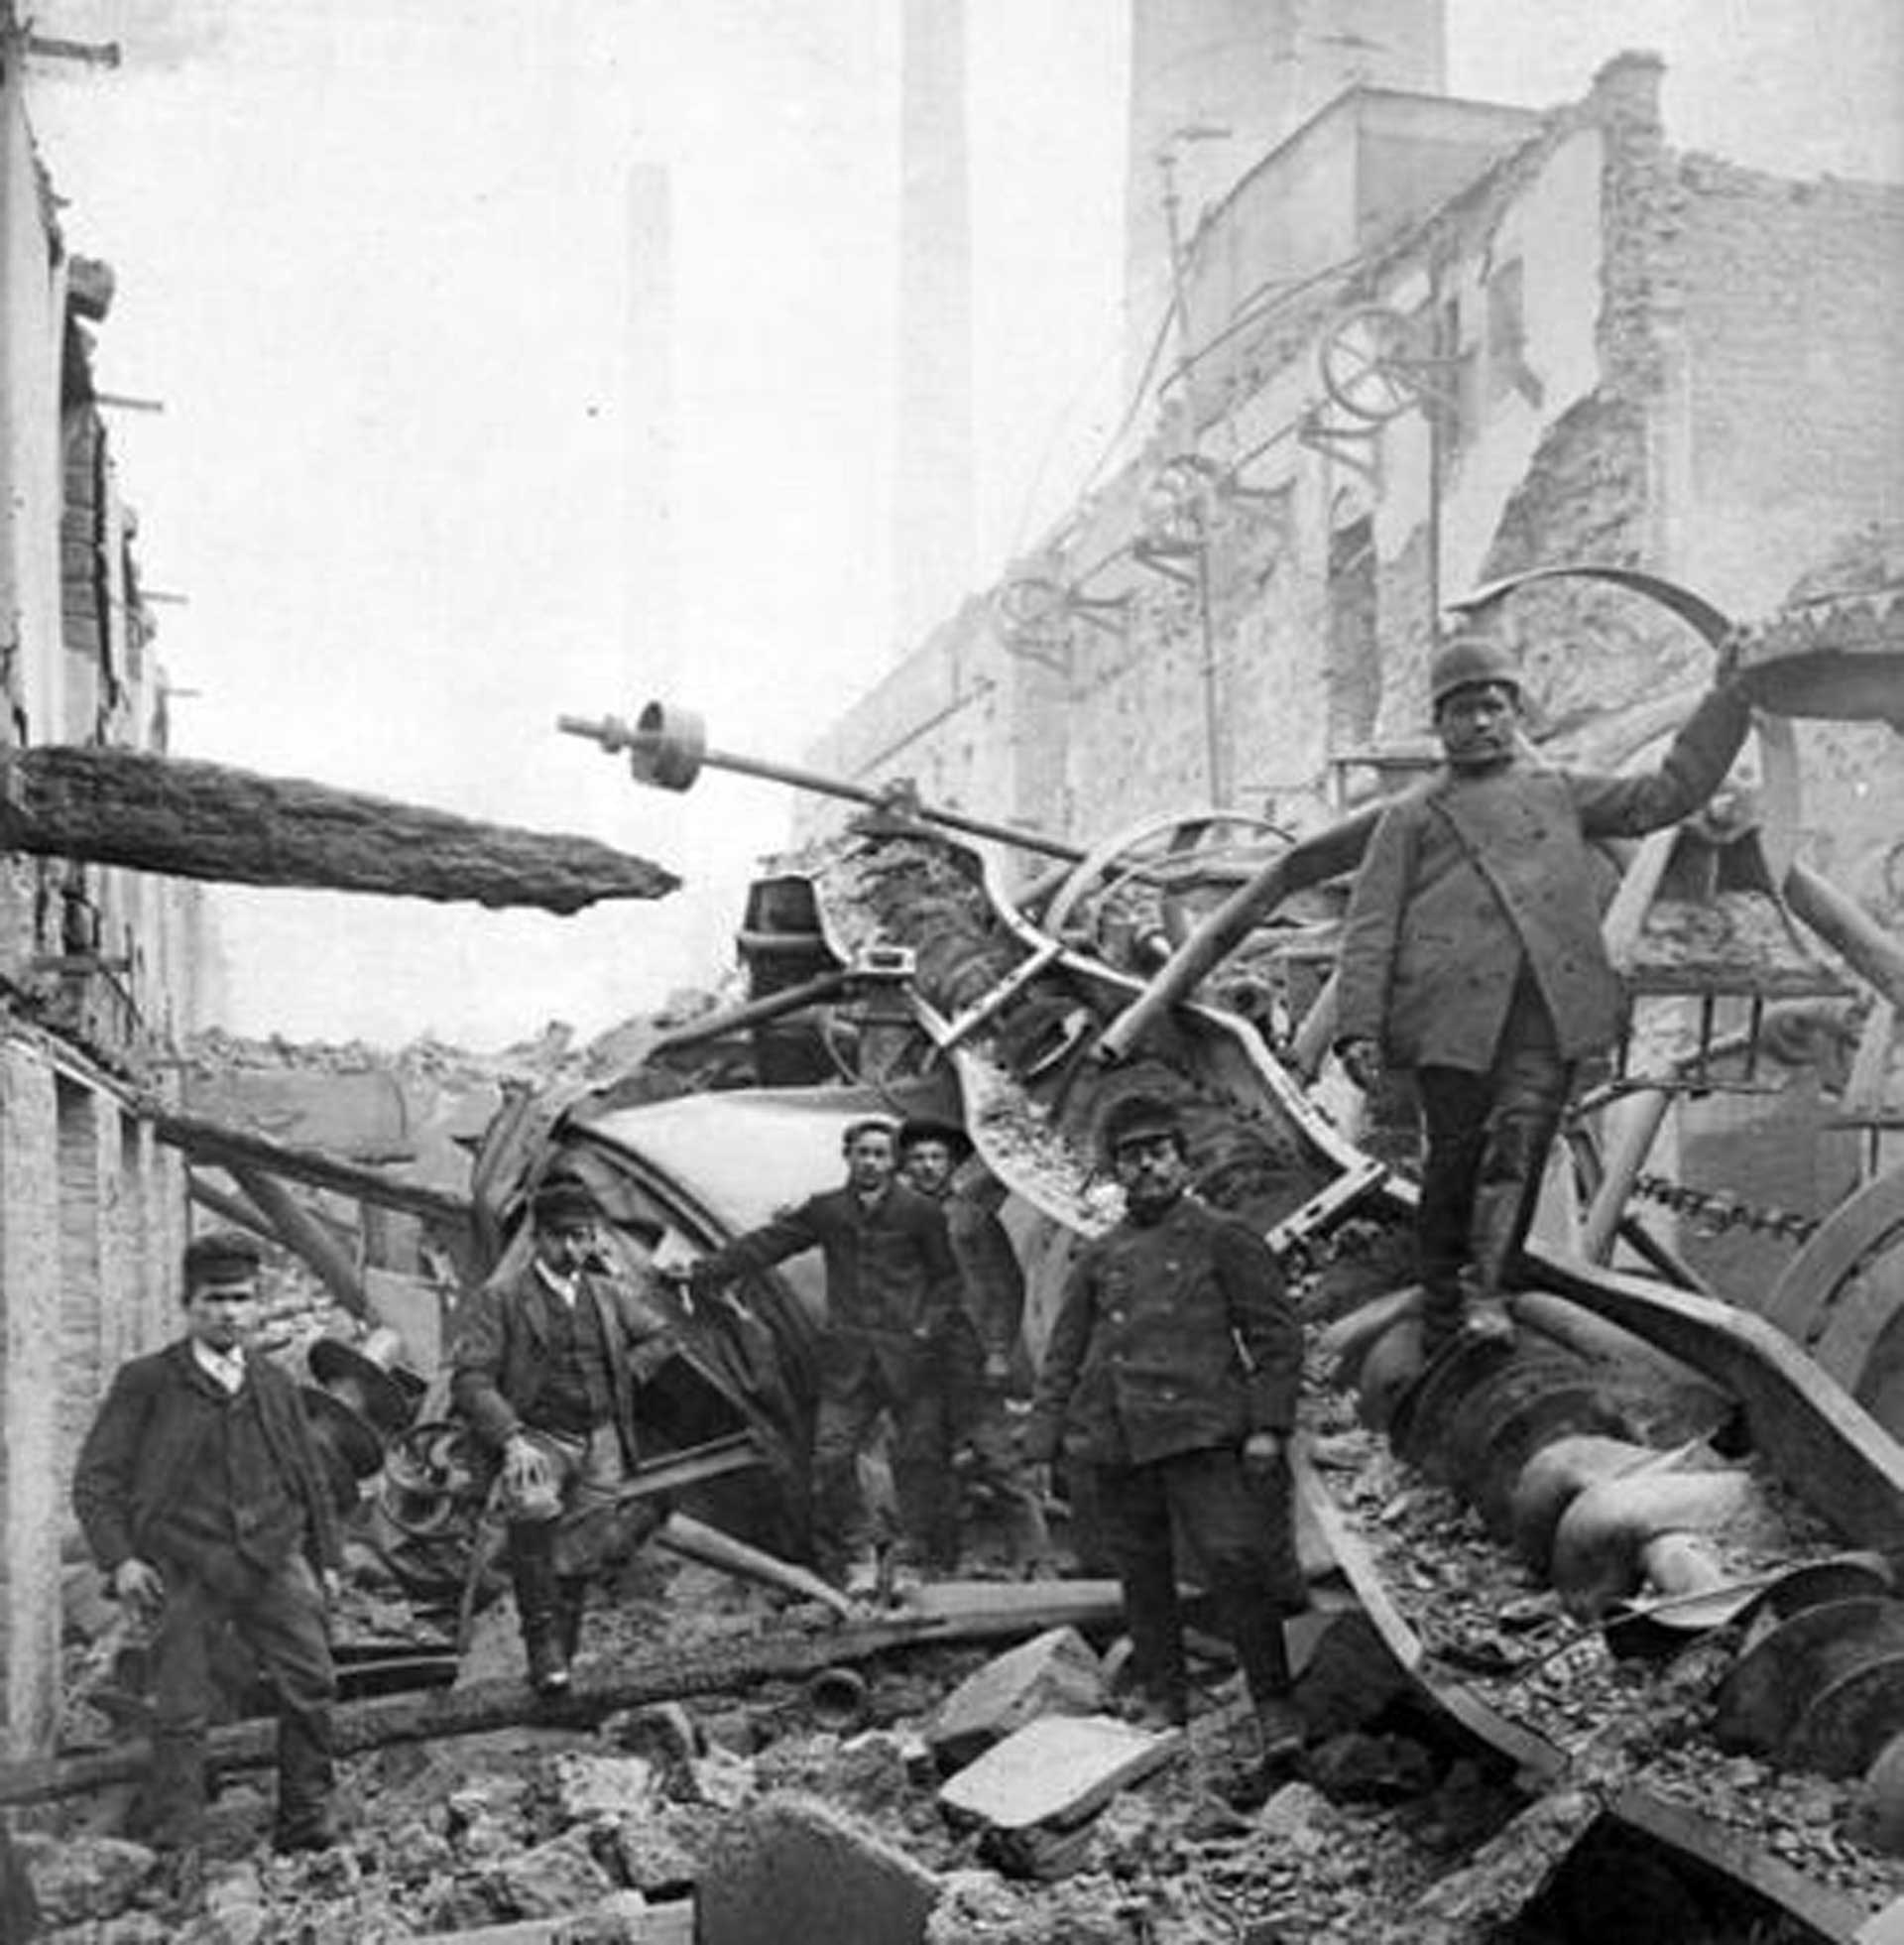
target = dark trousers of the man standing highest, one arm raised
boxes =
[1416,1010,1574,1338]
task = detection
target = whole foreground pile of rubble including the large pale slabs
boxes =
[16,1560,1555,1945]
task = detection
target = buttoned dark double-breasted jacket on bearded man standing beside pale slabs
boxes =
[1025,1194,1303,1465]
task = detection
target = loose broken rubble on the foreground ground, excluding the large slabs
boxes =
[22,1532,1563,1945]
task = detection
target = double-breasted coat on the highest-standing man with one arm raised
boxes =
[1336,686,1750,1073]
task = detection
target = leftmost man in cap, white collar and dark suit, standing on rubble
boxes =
[72,1231,340,1854]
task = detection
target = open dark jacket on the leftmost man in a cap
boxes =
[72,1338,342,1575]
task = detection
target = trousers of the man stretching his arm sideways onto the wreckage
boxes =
[813,1368,959,1573]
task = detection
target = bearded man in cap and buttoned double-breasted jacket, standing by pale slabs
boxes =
[1025,1095,1303,1768]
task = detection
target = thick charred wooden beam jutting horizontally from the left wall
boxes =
[0,743,680,912]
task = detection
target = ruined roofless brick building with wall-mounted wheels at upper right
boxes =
[801,55,1904,891]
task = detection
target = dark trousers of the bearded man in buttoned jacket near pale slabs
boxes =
[1093,1445,1289,1710]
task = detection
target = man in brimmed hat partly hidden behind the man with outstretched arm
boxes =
[898,1117,1050,1566]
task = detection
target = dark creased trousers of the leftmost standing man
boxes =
[148,1554,336,1846]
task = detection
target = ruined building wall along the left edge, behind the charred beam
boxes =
[0,38,204,1755]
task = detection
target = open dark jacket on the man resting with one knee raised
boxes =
[449,1263,678,1465]
